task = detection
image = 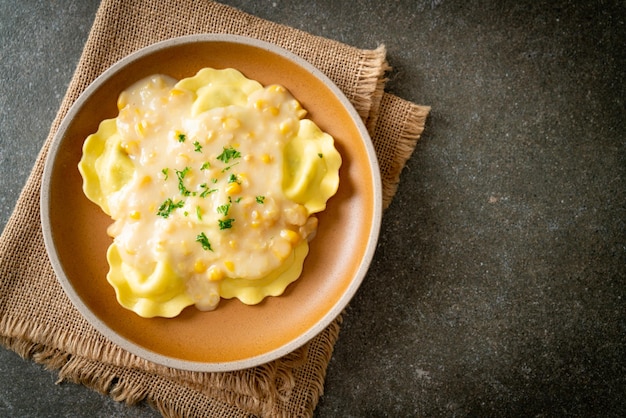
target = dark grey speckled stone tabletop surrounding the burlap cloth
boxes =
[0,0,626,417]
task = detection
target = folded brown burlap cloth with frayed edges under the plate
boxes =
[0,0,429,417]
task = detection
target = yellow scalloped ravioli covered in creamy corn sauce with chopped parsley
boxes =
[79,68,341,317]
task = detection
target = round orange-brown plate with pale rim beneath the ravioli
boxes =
[41,35,382,371]
